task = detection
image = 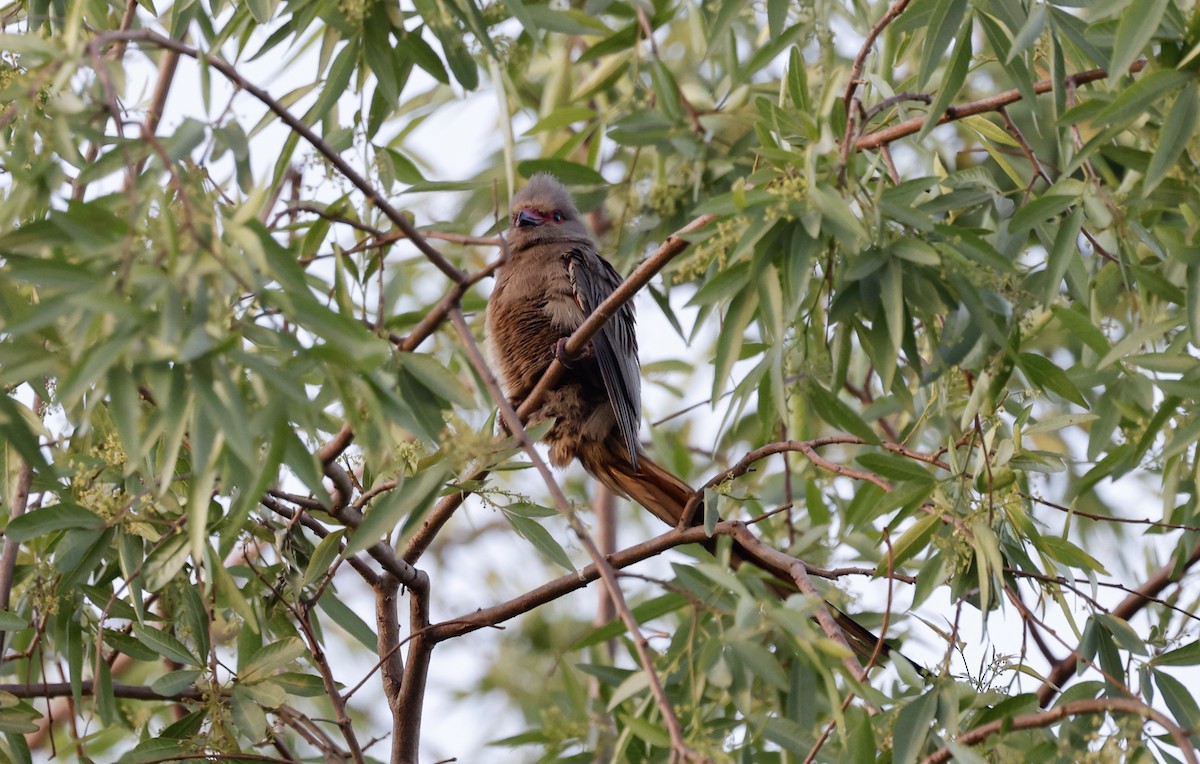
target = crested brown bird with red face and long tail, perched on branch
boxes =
[485,174,902,656]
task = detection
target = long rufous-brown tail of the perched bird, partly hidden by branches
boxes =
[577,439,911,662]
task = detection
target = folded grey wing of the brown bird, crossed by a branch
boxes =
[566,247,642,469]
